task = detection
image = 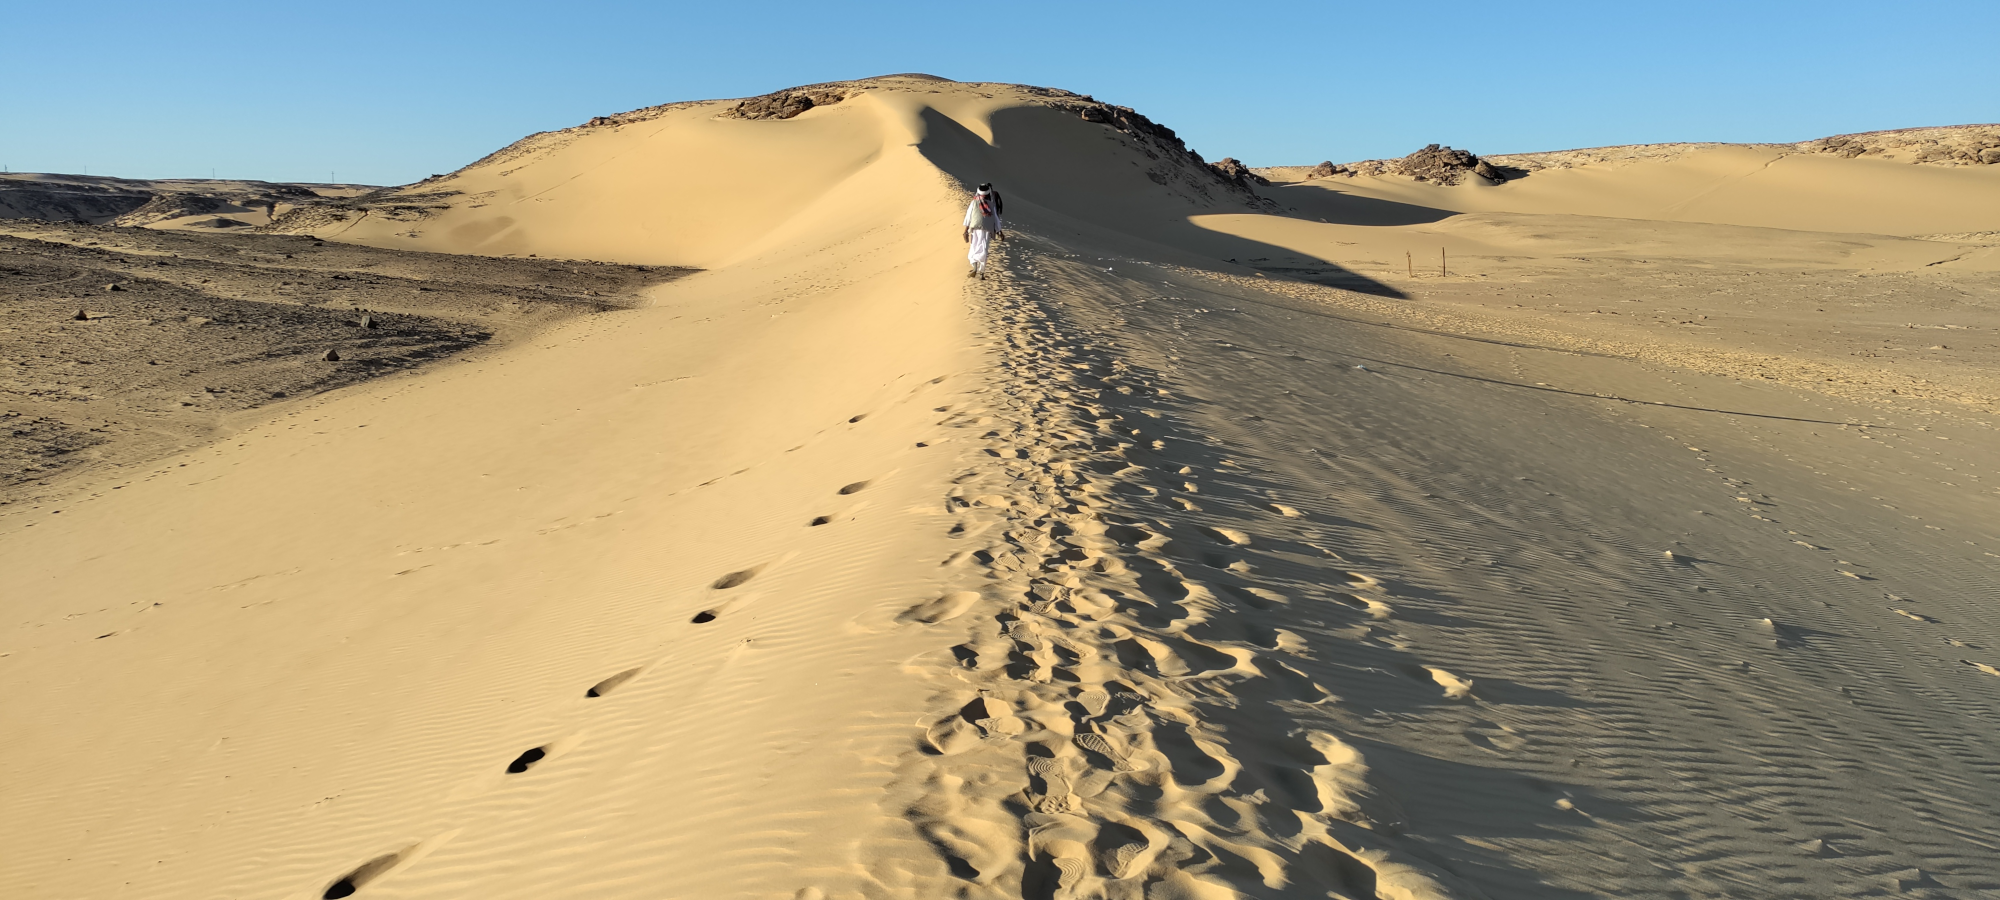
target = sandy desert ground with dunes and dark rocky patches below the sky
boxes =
[0,76,2000,900]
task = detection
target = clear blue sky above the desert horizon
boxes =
[0,0,2000,184]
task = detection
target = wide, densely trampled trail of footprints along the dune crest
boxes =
[902,244,1474,900]
